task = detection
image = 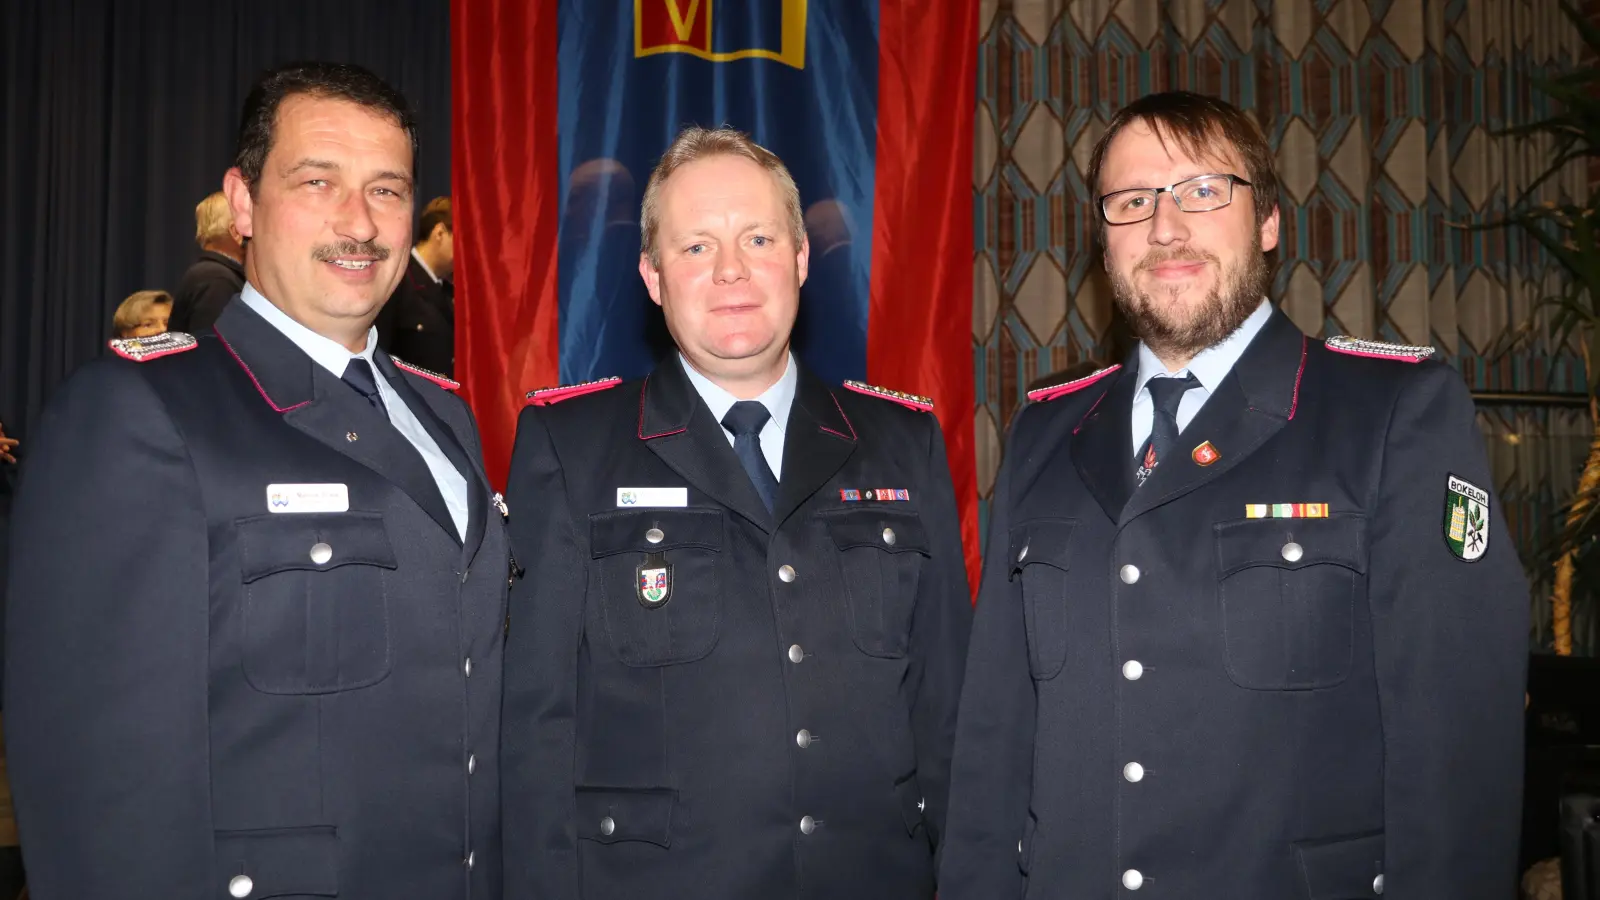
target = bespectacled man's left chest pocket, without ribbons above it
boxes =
[1010,519,1077,681]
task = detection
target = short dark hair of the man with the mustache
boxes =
[234,62,416,192]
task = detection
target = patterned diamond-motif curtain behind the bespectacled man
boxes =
[973,0,1586,554]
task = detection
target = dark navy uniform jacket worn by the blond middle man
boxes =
[502,360,971,900]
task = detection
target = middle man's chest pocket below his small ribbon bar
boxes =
[819,506,928,658]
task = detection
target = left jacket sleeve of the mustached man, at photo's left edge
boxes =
[5,360,218,900]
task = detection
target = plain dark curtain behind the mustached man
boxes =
[0,0,450,441]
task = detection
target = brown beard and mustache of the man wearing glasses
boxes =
[1106,235,1272,360]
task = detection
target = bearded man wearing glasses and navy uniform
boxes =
[939,93,1528,900]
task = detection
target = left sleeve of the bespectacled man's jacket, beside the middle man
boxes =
[939,410,1035,900]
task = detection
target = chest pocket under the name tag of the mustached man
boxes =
[234,512,397,693]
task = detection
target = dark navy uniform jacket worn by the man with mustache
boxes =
[5,299,509,900]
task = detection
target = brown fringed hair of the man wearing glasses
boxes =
[1088,91,1278,243]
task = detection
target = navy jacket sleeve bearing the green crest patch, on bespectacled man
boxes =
[1366,364,1528,900]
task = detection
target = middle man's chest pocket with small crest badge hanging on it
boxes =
[589,508,726,666]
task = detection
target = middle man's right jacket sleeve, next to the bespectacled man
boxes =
[910,415,973,847]
